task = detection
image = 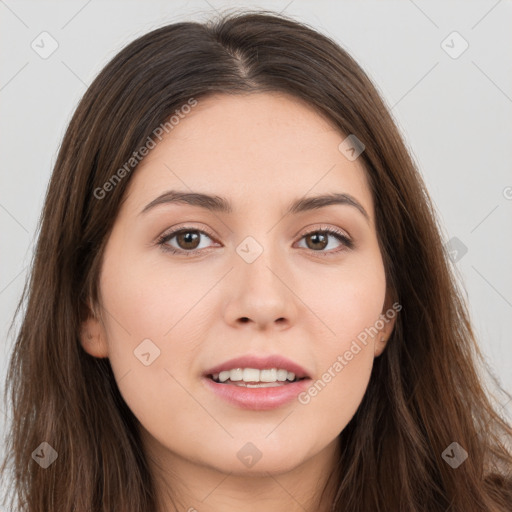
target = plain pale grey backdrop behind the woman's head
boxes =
[0,0,512,504]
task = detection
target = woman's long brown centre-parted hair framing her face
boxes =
[4,12,512,512]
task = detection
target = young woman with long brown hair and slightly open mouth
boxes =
[2,8,512,512]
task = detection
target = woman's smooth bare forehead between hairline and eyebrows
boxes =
[122,93,373,215]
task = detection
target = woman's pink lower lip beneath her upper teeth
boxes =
[203,377,311,411]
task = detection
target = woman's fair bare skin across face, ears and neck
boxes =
[82,93,394,512]
